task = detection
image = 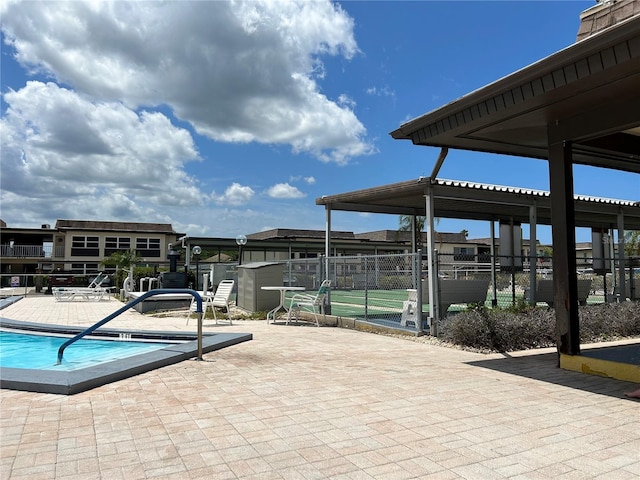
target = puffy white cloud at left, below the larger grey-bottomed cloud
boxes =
[0,82,202,214]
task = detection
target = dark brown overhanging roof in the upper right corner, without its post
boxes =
[391,15,640,173]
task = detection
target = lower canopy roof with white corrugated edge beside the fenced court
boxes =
[316,177,640,230]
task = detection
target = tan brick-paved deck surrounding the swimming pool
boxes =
[0,296,640,480]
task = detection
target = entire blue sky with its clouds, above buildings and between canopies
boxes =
[0,1,640,242]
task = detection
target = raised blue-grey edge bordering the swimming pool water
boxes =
[0,318,253,395]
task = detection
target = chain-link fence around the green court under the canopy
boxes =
[2,253,640,333]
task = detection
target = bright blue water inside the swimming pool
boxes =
[0,330,175,371]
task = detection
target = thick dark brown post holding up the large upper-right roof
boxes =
[549,141,580,355]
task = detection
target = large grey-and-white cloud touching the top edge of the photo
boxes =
[2,0,375,164]
